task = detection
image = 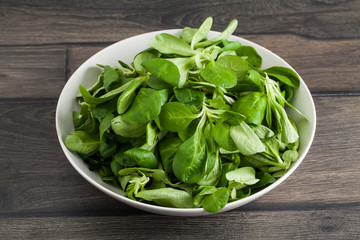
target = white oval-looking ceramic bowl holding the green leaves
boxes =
[56,29,316,216]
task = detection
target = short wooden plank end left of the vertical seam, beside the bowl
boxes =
[0,46,66,98]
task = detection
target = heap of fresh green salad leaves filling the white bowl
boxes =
[65,17,300,213]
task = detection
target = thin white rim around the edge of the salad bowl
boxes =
[55,29,316,216]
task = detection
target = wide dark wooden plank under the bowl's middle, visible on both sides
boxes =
[0,96,360,215]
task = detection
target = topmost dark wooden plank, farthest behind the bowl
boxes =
[0,0,360,45]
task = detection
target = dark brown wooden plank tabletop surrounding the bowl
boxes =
[0,0,360,239]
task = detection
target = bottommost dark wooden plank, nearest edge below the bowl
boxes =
[0,206,360,239]
